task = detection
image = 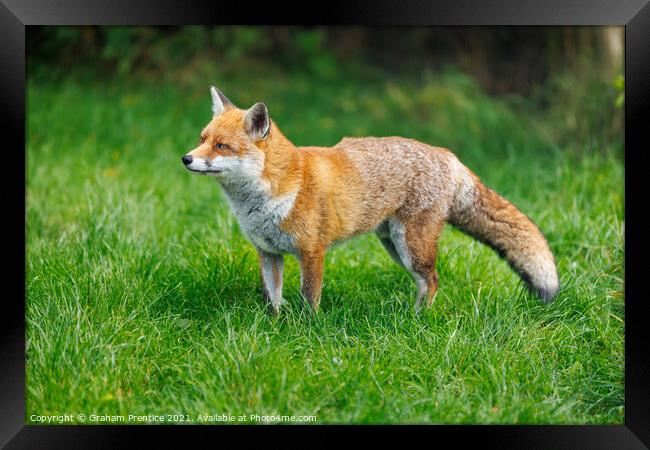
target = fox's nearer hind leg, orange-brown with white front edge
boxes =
[389,210,445,311]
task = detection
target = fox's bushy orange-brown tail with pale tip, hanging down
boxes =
[449,167,560,302]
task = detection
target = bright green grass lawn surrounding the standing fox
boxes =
[26,71,625,423]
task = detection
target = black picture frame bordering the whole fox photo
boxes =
[0,0,650,450]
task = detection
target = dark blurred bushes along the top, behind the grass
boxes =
[27,26,623,151]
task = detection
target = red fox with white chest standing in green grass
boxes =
[181,86,560,314]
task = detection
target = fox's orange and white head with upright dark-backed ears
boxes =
[181,86,271,181]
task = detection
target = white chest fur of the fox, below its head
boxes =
[219,180,297,254]
